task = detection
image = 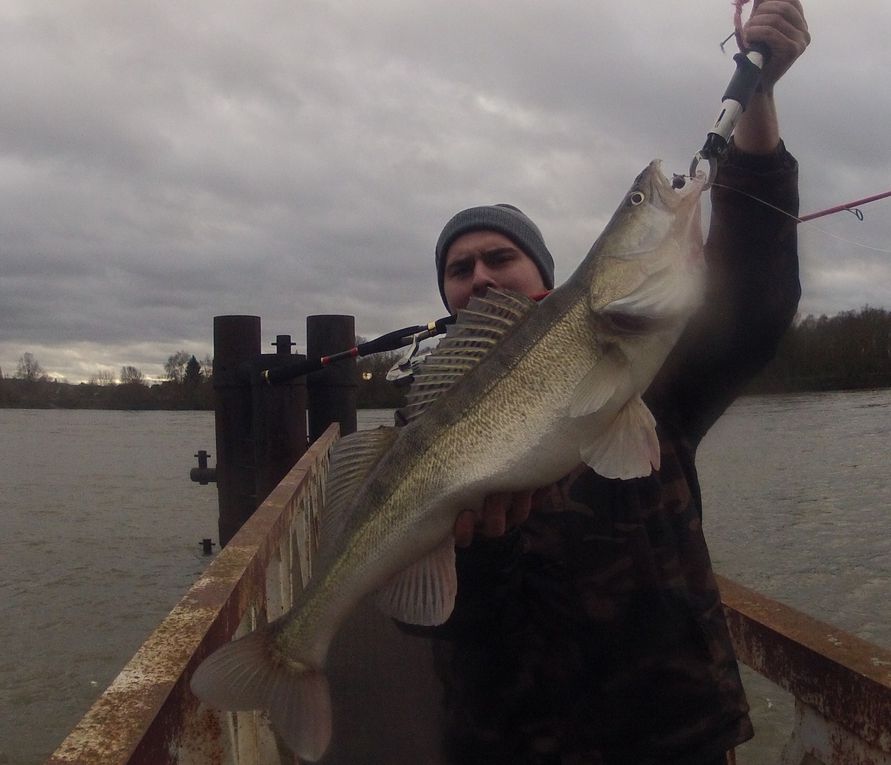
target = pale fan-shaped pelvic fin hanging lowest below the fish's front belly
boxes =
[579,396,659,479]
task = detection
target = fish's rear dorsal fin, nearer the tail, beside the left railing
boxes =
[320,427,398,547]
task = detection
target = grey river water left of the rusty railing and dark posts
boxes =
[0,409,217,765]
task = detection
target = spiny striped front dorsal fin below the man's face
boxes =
[402,289,535,421]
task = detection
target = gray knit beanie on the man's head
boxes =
[436,204,554,308]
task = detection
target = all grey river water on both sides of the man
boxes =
[0,391,891,765]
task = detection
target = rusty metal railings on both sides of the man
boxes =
[48,425,891,765]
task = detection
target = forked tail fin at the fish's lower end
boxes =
[191,630,331,762]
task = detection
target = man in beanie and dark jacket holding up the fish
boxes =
[433,0,810,765]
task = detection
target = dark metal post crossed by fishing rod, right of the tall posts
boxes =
[306,314,358,441]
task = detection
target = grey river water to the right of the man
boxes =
[697,390,891,765]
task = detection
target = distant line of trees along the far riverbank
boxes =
[0,306,891,409]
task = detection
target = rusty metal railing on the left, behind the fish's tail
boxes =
[47,425,338,765]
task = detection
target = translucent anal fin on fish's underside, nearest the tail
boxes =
[376,534,458,627]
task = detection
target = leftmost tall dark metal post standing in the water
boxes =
[213,316,260,546]
